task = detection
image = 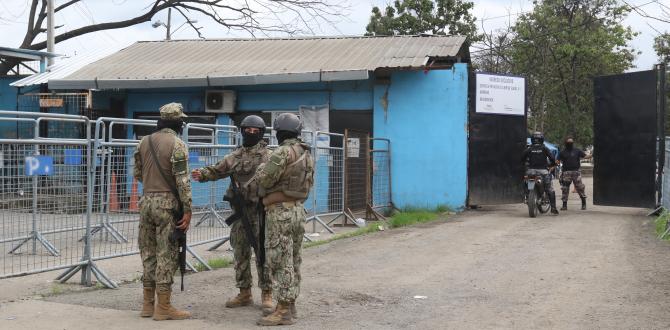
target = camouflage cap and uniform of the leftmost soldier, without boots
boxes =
[133,104,192,290]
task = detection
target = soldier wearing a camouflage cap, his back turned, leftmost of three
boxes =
[133,103,191,321]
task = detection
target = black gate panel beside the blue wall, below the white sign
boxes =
[468,75,527,206]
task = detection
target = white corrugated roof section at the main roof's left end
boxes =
[9,48,126,87]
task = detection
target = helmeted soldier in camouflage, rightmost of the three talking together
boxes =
[257,113,314,325]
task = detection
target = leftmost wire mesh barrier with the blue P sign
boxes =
[0,111,91,277]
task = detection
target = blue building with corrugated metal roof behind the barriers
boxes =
[49,36,470,209]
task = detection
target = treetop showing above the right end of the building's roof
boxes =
[366,0,480,42]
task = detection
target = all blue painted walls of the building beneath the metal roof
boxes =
[100,70,468,213]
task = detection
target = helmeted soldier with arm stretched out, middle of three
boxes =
[191,115,273,314]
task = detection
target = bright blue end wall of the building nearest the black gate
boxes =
[374,64,468,209]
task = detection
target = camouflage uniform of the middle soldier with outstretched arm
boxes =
[199,141,272,290]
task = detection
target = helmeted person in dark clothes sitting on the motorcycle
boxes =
[521,132,558,214]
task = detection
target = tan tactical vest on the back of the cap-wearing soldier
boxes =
[140,132,177,193]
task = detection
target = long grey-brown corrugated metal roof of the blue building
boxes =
[49,36,465,89]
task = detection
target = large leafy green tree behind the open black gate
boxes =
[508,0,636,144]
